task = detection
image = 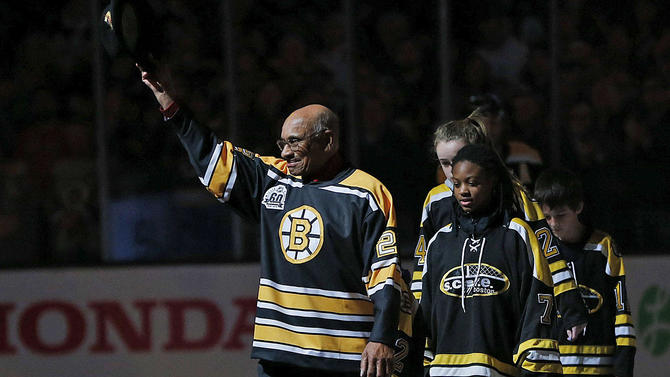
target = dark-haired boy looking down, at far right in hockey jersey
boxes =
[535,169,635,377]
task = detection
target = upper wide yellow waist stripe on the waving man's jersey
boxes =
[258,285,374,315]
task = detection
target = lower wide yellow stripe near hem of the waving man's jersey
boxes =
[254,325,367,353]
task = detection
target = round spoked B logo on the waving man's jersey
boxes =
[279,206,323,264]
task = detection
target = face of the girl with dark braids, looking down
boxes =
[451,161,496,215]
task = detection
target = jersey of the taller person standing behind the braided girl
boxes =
[411,182,586,328]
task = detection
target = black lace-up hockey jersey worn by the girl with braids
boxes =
[421,207,561,376]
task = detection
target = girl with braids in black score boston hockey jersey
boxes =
[421,144,561,376]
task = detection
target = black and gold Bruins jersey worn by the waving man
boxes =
[170,110,416,371]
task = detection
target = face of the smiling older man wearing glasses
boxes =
[281,113,332,179]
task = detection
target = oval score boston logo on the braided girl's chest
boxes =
[440,263,509,297]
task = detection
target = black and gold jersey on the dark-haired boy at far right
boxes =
[555,231,635,377]
